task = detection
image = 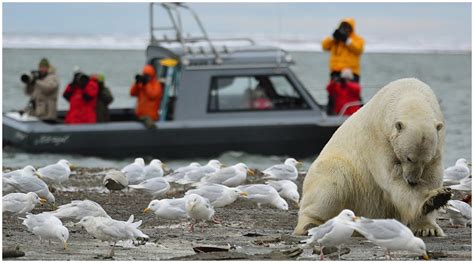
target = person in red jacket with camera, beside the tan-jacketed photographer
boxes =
[63,72,99,124]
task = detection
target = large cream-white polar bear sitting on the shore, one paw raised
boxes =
[294,78,451,236]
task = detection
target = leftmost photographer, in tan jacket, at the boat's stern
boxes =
[20,58,59,122]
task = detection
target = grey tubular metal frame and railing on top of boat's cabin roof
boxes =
[150,3,255,64]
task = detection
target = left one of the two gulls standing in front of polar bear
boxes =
[301,209,355,260]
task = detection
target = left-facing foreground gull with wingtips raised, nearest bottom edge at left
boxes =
[78,215,150,257]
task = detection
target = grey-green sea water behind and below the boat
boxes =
[2,48,472,169]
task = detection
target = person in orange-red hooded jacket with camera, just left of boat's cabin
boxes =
[130,65,163,124]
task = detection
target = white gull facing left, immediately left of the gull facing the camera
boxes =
[143,197,188,224]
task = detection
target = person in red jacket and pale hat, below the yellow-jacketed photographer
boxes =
[326,68,361,115]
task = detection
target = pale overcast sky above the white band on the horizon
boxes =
[3,3,471,43]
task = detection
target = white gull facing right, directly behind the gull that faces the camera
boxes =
[185,184,247,208]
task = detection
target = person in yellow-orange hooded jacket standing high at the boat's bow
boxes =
[322,18,364,82]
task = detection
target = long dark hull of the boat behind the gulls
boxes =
[3,113,339,158]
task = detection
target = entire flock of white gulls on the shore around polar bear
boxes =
[2,158,471,259]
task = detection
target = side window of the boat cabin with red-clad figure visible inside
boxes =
[209,75,309,112]
